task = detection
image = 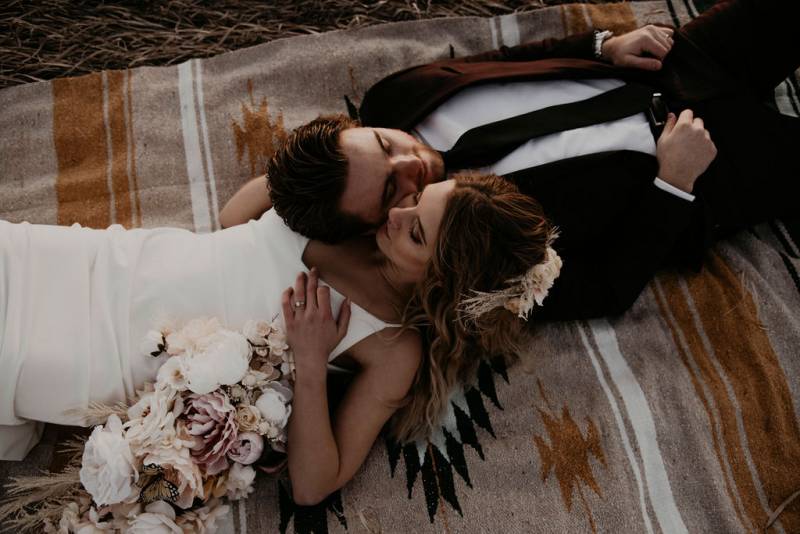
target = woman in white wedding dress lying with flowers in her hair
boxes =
[0,176,560,505]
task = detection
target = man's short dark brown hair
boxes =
[267,115,369,243]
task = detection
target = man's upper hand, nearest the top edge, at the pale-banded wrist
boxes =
[602,24,673,70]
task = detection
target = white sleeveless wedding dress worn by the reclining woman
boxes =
[0,210,388,460]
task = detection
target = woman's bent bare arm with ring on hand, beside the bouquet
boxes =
[283,271,421,505]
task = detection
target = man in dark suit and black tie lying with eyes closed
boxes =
[223,0,800,318]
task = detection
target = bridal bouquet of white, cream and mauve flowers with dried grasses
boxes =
[0,319,294,534]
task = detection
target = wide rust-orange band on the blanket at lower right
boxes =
[660,255,800,532]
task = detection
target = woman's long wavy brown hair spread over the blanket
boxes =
[390,175,551,441]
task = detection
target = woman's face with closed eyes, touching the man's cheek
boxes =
[375,180,455,282]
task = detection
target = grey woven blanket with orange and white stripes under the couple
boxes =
[0,0,800,533]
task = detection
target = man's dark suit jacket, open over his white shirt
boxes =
[359,33,730,319]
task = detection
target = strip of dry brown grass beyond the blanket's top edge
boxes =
[0,0,636,88]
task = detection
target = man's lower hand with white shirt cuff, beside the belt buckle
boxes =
[656,109,717,193]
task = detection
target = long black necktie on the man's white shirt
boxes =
[442,83,653,170]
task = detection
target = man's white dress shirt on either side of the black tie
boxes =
[412,78,694,201]
